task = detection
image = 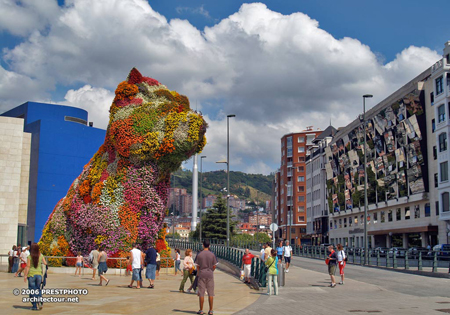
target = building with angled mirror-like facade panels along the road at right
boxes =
[325,42,450,248]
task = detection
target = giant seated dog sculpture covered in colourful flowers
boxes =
[39,68,207,264]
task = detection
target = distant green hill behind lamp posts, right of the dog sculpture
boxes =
[171,170,274,203]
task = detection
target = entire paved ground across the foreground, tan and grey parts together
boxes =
[0,257,450,315]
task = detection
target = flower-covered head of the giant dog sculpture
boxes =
[105,68,207,173]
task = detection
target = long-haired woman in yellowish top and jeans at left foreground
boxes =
[23,243,47,311]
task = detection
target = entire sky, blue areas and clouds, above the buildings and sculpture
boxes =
[0,0,450,174]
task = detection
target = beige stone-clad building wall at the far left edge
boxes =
[0,116,31,254]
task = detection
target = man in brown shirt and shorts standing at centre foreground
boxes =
[195,240,218,315]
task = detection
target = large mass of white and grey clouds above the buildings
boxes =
[0,0,440,172]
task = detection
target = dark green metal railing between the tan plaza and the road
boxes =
[168,239,267,287]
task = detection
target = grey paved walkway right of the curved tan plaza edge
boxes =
[236,262,450,315]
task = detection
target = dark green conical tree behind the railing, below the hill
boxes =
[194,196,234,239]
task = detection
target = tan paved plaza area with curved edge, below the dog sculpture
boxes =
[0,270,259,315]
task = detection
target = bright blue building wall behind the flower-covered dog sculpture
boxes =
[1,102,106,242]
